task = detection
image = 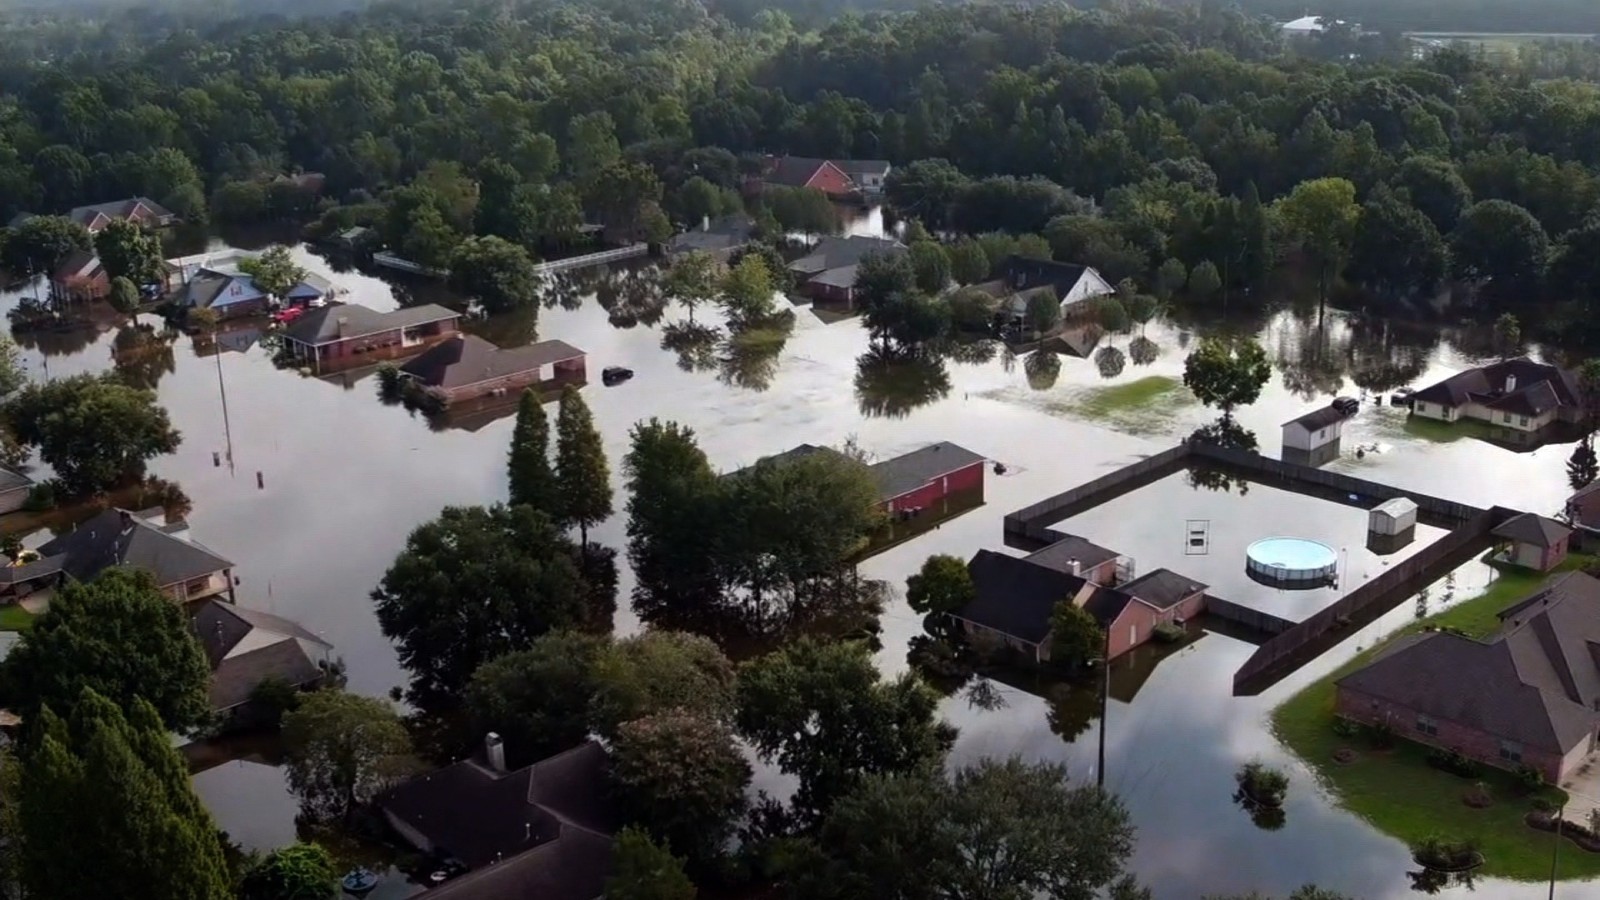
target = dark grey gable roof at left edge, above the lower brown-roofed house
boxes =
[38,509,234,588]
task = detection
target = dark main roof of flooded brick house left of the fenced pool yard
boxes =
[955,549,1088,644]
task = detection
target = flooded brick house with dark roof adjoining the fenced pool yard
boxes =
[952,548,1206,663]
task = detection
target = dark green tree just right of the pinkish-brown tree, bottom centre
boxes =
[738,637,955,825]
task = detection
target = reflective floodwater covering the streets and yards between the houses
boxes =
[5,219,1600,900]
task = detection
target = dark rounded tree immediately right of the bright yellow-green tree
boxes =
[1350,189,1450,296]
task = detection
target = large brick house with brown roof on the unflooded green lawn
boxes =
[1334,572,1600,783]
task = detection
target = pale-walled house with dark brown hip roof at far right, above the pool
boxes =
[1411,357,1586,432]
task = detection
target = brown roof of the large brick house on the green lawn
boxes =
[1336,572,1600,754]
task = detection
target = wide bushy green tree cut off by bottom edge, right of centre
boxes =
[784,757,1147,900]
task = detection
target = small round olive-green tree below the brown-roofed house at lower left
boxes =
[283,690,411,822]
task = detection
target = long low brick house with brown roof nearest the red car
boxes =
[283,303,461,370]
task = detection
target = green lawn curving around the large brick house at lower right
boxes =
[1272,557,1600,881]
